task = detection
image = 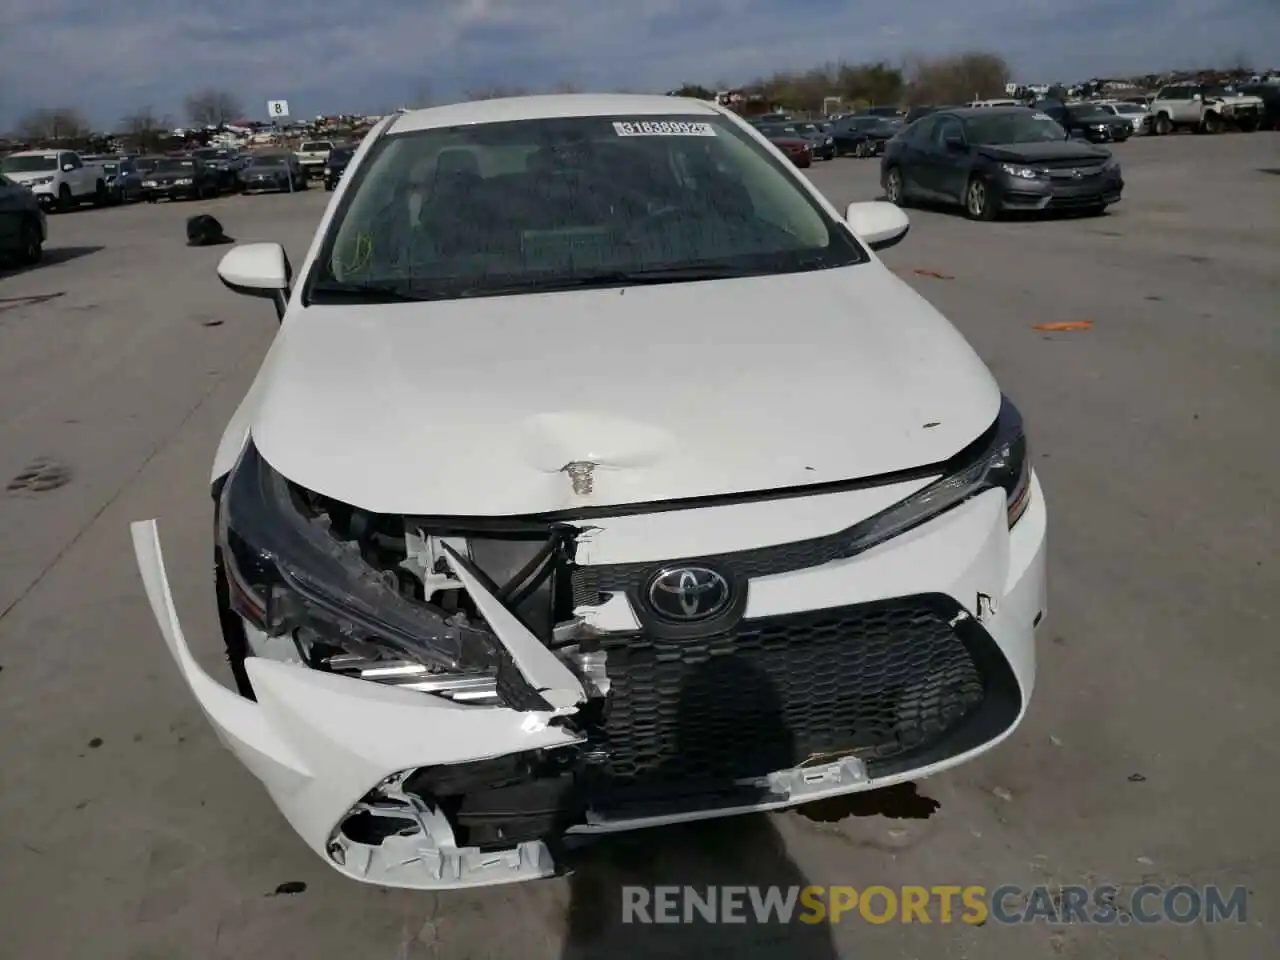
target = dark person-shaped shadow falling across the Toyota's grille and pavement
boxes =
[563,657,837,960]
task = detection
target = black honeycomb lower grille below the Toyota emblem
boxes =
[583,594,1019,797]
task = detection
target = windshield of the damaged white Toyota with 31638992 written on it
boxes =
[307,114,868,302]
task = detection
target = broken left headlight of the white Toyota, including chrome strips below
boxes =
[216,443,499,704]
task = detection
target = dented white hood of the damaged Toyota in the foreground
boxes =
[248,261,1000,516]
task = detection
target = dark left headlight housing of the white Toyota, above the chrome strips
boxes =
[215,443,497,678]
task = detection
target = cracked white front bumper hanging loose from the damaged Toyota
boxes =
[132,475,1047,888]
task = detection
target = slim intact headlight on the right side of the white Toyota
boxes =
[855,397,1032,553]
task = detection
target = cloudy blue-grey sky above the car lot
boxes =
[0,0,1280,131]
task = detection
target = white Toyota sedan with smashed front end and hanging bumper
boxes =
[133,95,1046,888]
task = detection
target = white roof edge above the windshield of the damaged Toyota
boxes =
[387,93,722,133]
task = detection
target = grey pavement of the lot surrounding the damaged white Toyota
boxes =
[0,133,1280,960]
